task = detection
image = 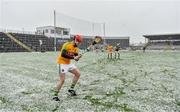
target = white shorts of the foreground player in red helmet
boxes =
[59,64,77,74]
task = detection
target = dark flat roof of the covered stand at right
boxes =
[143,34,180,40]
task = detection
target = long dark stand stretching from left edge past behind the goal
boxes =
[0,32,129,52]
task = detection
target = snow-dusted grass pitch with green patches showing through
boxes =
[0,51,180,112]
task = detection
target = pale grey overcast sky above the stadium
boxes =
[0,0,180,43]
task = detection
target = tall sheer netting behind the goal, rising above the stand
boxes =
[56,12,104,36]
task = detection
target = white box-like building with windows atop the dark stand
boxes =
[36,26,70,38]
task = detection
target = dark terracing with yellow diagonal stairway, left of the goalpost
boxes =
[0,32,54,52]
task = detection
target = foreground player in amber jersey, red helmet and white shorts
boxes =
[52,35,82,101]
